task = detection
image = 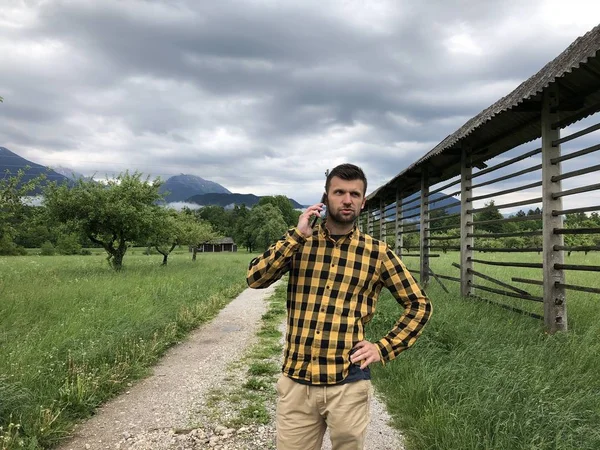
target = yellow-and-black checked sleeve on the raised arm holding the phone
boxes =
[246,228,306,289]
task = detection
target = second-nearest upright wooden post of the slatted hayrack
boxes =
[460,147,473,297]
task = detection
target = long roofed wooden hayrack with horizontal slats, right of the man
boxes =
[359,27,600,332]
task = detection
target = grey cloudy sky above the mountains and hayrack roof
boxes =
[0,0,600,204]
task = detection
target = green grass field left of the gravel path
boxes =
[0,251,250,449]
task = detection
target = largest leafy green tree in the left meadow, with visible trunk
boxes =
[44,172,164,270]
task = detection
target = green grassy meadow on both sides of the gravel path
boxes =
[0,249,600,450]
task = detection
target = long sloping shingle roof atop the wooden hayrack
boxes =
[367,25,600,203]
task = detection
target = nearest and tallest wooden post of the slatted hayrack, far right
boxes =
[542,83,567,333]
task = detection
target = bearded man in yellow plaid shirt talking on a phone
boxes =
[247,164,431,450]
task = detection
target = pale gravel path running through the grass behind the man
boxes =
[59,286,403,450]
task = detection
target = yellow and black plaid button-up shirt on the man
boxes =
[247,224,431,385]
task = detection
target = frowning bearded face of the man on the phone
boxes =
[327,177,365,224]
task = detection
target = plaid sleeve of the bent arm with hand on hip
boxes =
[376,247,432,363]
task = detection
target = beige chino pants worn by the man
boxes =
[277,375,372,450]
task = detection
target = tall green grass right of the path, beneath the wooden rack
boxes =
[368,254,600,450]
